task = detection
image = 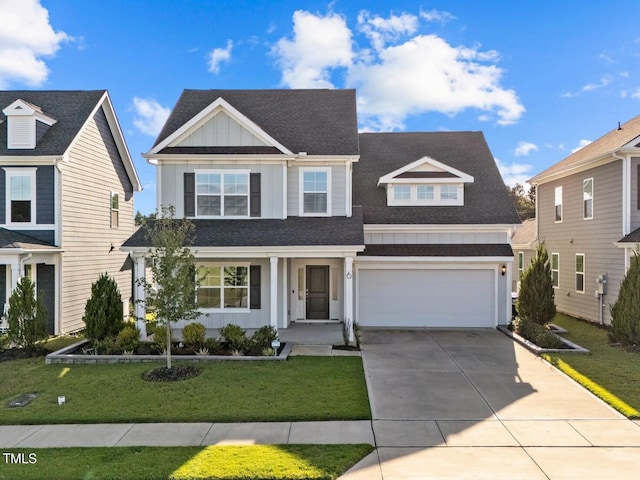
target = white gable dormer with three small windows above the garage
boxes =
[378,157,473,207]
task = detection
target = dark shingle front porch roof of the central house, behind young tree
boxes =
[123,208,364,249]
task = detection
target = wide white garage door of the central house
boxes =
[357,269,496,328]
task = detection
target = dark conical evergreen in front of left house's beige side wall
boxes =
[82,273,124,341]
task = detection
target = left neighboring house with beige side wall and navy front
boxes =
[0,90,140,334]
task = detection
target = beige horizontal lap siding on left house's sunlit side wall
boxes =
[60,109,134,332]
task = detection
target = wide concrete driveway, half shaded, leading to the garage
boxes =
[343,330,640,480]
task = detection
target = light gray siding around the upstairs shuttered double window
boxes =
[158,162,287,218]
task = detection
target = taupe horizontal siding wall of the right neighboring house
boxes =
[537,160,625,323]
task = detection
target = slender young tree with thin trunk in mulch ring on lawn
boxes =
[141,206,200,368]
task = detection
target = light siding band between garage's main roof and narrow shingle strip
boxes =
[364,227,509,245]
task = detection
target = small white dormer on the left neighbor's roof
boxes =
[2,99,56,149]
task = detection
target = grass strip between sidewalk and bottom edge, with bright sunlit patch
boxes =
[0,445,373,480]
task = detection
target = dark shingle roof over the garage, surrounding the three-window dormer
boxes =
[353,132,520,225]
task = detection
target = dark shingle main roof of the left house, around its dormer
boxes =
[0,90,106,156]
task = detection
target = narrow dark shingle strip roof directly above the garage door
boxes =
[358,243,513,257]
